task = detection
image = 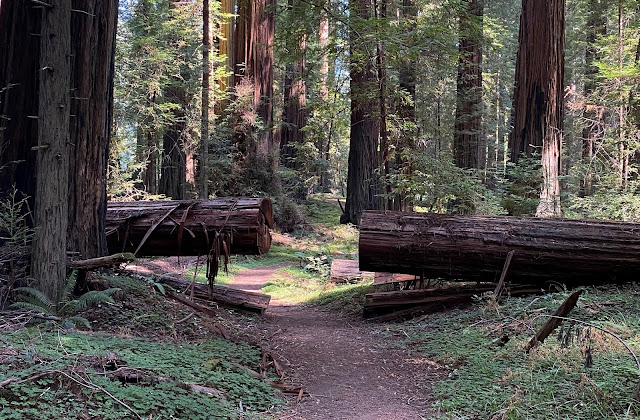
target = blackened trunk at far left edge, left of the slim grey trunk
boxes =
[0,0,42,202]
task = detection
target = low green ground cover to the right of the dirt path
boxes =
[391,285,640,420]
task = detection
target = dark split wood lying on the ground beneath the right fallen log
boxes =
[363,285,541,321]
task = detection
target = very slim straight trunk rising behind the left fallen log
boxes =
[199,0,211,199]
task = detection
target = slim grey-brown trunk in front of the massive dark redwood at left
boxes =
[32,0,71,302]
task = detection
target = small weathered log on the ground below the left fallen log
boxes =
[156,276,271,314]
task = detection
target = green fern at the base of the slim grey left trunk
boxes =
[11,270,120,328]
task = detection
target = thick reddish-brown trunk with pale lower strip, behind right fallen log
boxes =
[509,0,565,217]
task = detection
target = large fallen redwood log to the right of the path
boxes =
[359,211,640,287]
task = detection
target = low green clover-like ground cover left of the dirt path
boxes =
[0,330,282,419]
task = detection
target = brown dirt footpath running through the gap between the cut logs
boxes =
[230,265,437,420]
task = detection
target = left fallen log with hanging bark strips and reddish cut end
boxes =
[106,197,273,256]
